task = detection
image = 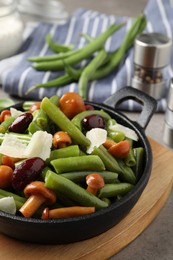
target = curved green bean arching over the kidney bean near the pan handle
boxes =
[71,110,111,130]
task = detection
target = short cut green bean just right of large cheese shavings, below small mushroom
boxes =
[46,145,80,163]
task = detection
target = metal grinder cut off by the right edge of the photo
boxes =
[163,79,173,149]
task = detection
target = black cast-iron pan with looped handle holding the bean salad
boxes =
[0,87,156,244]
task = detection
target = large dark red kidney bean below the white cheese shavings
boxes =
[12,157,45,190]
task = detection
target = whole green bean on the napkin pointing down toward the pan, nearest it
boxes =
[78,50,107,99]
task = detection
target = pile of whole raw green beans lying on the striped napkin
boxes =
[26,15,146,99]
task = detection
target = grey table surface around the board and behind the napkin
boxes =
[0,0,173,260]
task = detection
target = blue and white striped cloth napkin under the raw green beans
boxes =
[2,0,173,111]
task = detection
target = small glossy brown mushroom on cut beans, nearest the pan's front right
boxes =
[86,173,105,195]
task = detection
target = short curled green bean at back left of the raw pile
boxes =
[46,33,74,53]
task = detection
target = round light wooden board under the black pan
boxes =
[0,139,173,260]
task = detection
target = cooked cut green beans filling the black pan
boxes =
[0,96,145,218]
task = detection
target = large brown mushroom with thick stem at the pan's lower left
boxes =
[19,181,56,218]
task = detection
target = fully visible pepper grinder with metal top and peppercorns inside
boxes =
[132,33,172,100]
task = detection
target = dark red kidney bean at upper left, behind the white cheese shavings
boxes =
[8,113,33,133]
